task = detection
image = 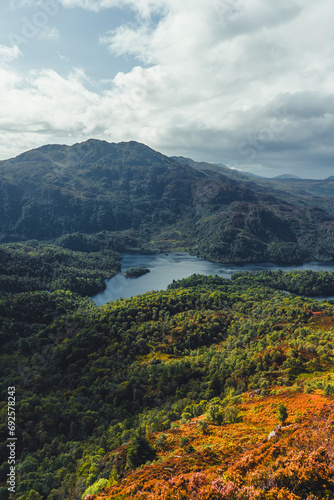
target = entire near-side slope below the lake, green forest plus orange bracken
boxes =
[0,260,334,500]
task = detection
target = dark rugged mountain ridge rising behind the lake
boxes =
[0,140,334,263]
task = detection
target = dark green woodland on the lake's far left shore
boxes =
[0,242,120,295]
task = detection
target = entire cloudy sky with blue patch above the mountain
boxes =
[0,0,334,178]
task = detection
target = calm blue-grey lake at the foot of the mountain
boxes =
[92,252,334,306]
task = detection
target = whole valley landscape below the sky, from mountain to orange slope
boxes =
[0,140,334,500]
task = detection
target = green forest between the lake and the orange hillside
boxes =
[0,276,334,500]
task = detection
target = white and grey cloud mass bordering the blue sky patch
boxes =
[0,0,334,176]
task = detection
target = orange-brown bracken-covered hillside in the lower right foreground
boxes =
[94,388,334,500]
